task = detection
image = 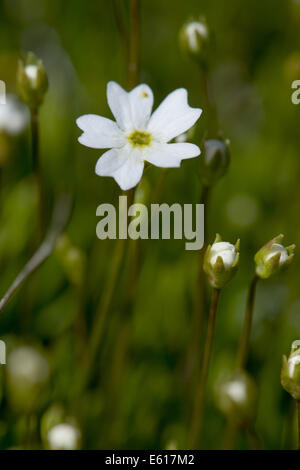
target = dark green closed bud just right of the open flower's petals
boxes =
[199,139,230,186]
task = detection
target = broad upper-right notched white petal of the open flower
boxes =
[148,88,202,142]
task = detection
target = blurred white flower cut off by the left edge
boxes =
[0,94,29,135]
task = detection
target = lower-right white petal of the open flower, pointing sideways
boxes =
[145,143,200,168]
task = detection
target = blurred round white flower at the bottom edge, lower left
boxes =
[47,423,81,450]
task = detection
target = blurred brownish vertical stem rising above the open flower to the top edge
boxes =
[128,0,140,90]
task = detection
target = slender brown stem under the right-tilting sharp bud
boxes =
[237,276,259,369]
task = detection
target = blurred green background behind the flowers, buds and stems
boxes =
[0,0,300,449]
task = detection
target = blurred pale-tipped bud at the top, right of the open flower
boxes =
[179,18,210,65]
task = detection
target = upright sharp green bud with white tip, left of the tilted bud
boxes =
[203,234,240,289]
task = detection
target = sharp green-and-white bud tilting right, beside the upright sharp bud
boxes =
[254,234,295,279]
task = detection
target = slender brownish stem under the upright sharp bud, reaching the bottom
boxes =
[189,288,220,449]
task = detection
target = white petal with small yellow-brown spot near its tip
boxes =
[129,84,153,129]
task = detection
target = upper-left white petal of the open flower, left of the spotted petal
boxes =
[106,82,132,131]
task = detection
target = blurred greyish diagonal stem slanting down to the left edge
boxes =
[0,195,71,313]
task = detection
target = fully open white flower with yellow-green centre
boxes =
[76,82,202,190]
